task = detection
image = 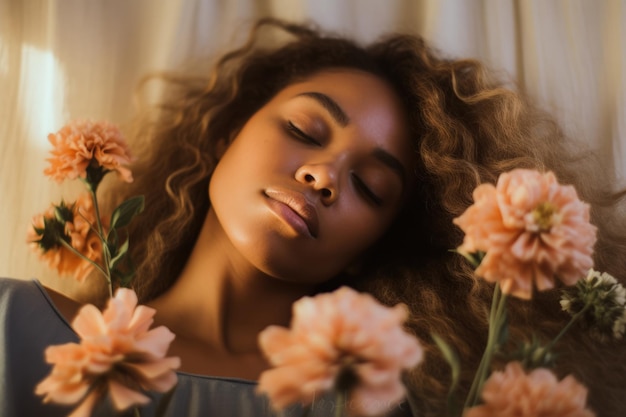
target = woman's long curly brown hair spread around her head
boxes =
[110,19,626,416]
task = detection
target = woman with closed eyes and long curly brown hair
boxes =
[2,20,626,416]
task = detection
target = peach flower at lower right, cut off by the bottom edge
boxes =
[464,362,595,417]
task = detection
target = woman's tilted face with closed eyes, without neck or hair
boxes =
[209,69,414,284]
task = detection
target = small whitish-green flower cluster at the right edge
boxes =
[561,269,626,340]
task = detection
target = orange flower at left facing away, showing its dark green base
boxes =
[27,193,102,281]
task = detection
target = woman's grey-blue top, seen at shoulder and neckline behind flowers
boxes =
[0,278,411,417]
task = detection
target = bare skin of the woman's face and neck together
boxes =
[142,69,413,379]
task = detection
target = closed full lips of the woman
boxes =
[265,188,319,238]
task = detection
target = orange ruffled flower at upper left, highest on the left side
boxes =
[44,121,133,182]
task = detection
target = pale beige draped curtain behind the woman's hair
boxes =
[0,0,626,296]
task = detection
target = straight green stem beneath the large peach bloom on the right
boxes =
[464,284,506,408]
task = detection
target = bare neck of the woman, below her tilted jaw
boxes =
[150,212,312,354]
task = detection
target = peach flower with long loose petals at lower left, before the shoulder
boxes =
[35,288,180,417]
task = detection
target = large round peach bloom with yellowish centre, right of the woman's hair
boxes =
[454,169,596,299]
